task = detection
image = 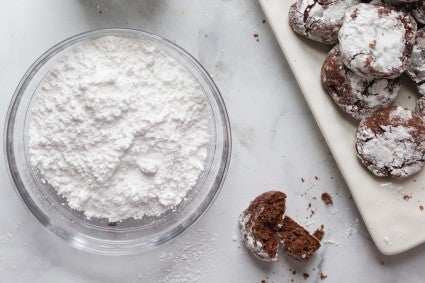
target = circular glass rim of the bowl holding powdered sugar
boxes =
[3,28,232,255]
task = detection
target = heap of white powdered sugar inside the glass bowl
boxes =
[29,36,210,221]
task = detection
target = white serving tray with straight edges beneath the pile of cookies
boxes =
[259,0,425,255]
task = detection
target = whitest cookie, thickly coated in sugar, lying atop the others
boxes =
[338,3,417,78]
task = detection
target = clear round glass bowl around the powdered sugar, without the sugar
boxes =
[4,29,231,255]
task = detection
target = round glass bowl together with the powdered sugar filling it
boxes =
[5,29,231,254]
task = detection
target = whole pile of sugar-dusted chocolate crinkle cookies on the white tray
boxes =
[289,0,425,178]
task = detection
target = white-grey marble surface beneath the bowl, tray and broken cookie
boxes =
[0,0,425,282]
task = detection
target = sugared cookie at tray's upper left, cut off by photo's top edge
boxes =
[285,0,360,44]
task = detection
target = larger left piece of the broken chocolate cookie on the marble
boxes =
[239,191,286,261]
